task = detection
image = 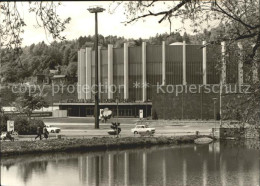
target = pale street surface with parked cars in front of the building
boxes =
[36,117,219,138]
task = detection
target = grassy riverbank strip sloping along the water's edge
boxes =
[1,135,212,156]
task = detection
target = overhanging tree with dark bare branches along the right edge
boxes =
[117,0,260,124]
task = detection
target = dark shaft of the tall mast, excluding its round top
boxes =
[95,12,99,129]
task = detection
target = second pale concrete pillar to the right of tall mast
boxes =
[107,44,113,99]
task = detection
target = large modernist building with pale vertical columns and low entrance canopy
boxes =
[55,41,256,117]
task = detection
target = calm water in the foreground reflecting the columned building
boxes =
[1,141,260,186]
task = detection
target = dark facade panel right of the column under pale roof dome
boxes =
[186,45,203,84]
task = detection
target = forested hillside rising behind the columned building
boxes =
[0,30,214,83]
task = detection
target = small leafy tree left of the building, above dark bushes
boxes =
[13,87,49,120]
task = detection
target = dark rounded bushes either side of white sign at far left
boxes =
[0,115,44,135]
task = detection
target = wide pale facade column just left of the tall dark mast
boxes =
[86,48,92,99]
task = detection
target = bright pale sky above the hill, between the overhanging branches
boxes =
[20,1,195,46]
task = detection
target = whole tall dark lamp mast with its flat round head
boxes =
[88,6,105,129]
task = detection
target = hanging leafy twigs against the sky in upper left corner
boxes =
[0,1,70,51]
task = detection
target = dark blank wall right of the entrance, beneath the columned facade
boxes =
[152,85,219,119]
